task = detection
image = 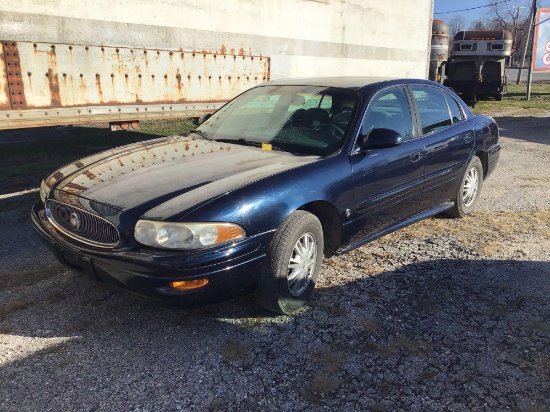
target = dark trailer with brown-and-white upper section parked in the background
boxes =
[442,30,512,104]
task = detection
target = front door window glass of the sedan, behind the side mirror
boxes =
[361,87,413,140]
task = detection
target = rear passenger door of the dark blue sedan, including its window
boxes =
[410,85,474,210]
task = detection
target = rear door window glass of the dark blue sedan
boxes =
[411,86,453,134]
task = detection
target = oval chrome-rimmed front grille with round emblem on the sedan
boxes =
[46,199,120,247]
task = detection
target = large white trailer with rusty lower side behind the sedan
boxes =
[0,0,433,129]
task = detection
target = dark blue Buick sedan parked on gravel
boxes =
[32,78,500,313]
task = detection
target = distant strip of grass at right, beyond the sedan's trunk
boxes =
[473,82,550,114]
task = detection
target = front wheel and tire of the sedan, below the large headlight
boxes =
[256,210,323,314]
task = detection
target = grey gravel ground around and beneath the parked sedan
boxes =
[0,113,550,412]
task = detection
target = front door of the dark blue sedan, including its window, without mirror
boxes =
[346,86,424,244]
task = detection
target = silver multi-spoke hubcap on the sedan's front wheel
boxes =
[287,233,317,296]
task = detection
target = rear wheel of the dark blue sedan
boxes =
[447,156,483,218]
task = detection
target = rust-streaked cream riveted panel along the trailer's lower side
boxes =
[0,42,270,111]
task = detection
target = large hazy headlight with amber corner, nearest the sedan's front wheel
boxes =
[134,220,246,249]
